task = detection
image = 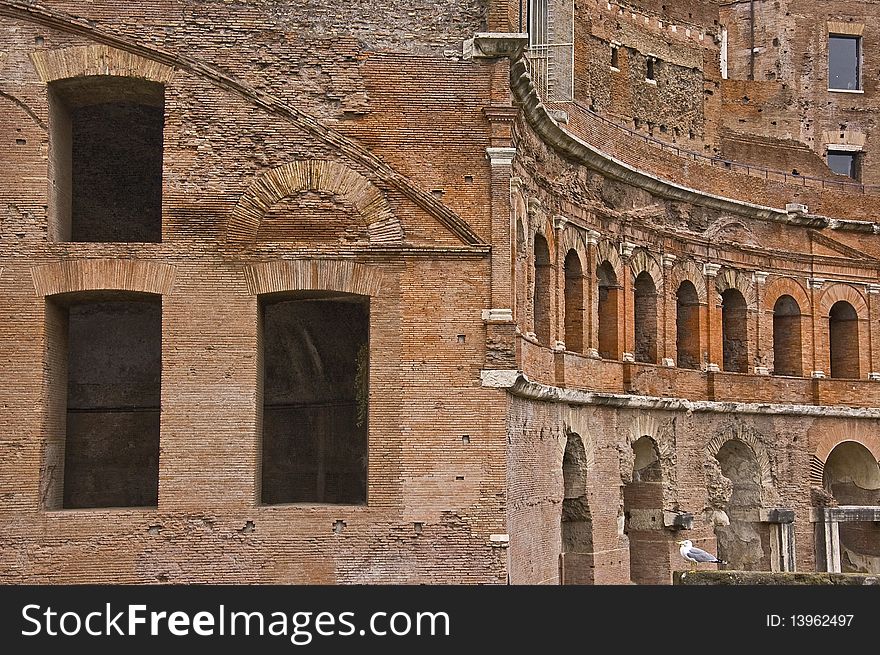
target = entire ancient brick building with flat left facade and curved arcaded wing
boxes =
[0,0,880,584]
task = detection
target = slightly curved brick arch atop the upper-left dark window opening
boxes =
[31,44,174,84]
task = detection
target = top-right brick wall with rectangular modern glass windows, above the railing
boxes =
[721,0,880,184]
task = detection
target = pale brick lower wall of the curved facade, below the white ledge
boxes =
[509,396,878,584]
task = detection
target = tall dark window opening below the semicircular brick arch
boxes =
[260,293,369,505]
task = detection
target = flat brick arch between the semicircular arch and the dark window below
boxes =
[244,259,384,296]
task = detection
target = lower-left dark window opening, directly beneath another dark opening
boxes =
[47,293,162,509]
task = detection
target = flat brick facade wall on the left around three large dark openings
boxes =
[0,1,507,584]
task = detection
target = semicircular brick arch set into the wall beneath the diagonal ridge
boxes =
[226,159,403,243]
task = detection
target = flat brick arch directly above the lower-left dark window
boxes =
[31,259,177,296]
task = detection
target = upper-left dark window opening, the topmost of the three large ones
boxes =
[49,76,165,242]
